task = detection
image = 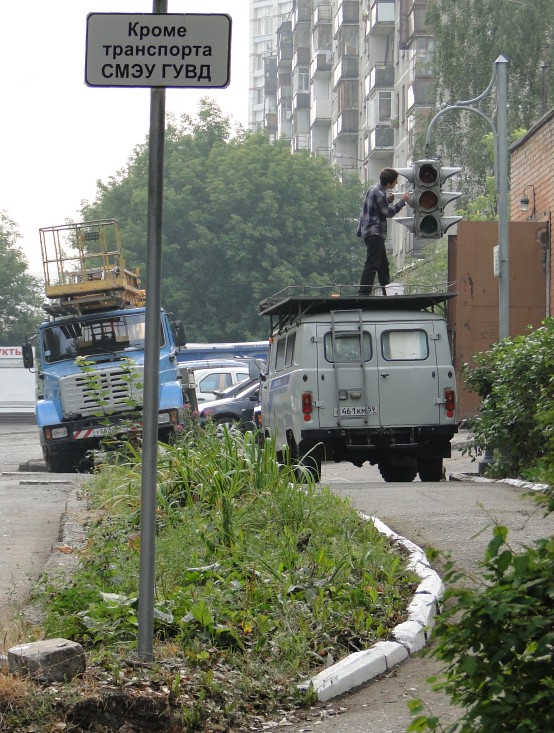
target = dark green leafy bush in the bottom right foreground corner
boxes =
[408,526,554,733]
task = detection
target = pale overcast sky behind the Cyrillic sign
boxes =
[0,0,249,273]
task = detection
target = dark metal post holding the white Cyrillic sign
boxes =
[138,0,167,661]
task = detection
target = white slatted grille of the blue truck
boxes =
[60,369,143,417]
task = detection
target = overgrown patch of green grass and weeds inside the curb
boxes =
[4,424,418,731]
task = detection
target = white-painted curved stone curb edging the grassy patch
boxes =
[299,514,444,702]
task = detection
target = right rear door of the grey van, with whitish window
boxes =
[375,320,440,427]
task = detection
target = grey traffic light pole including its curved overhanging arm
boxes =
[425,54,510,339]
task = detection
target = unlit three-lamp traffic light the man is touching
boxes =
[396,160,462,239]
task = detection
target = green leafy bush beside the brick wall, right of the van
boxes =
[465,318,554,476]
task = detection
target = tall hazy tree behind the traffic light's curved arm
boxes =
[427,0,554,196]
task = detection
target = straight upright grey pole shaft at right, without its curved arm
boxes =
[495,55,510,339]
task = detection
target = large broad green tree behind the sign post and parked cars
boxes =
[77,100,364,341]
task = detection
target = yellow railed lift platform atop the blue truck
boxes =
[39,219,145,315]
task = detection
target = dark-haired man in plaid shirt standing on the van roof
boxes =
[357,168,410,295]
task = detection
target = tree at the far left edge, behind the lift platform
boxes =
[0,212,43,346]
